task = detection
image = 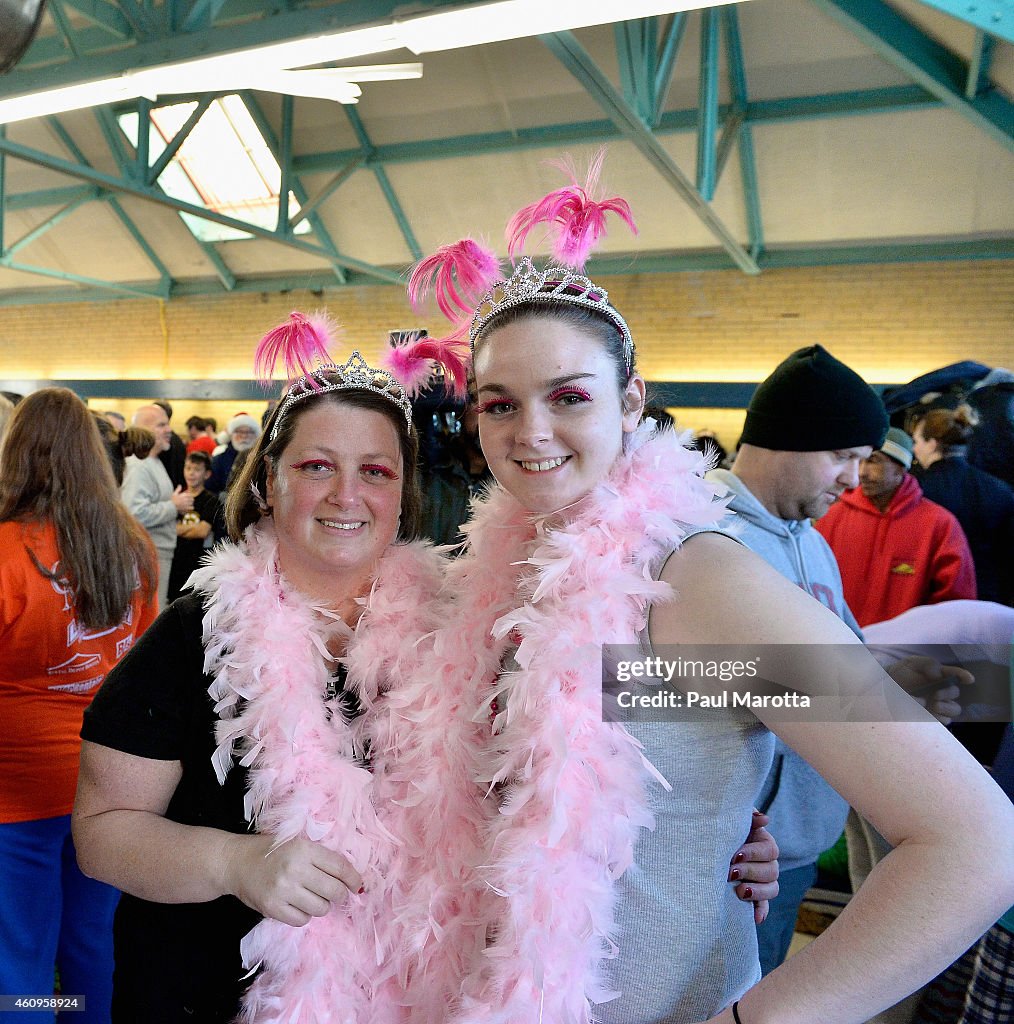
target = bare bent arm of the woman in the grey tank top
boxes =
[651,535,1014,1024]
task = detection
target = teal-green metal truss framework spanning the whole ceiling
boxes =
[0,0,1014,305]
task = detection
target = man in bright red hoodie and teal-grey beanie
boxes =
[816,427,976,626]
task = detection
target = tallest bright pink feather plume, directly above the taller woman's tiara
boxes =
[507,150,637,270]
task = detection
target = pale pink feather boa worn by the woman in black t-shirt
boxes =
[194,520,485,1024]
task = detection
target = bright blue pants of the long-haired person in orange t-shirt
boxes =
[0,814,120,1024]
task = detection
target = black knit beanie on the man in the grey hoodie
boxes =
[743,345,888,452]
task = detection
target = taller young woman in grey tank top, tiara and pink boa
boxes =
[397,153,1014,1024]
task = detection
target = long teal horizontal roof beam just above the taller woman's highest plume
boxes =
[293,85,939,174]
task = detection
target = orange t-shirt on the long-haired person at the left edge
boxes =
[0,522,157,823]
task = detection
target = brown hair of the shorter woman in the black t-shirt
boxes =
[225,388,422,541]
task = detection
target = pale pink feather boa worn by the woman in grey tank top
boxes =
[434,419,724,1024]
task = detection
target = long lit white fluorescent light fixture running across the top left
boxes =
[0,0,743,124]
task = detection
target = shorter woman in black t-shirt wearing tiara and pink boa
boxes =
[75,329,462,1024]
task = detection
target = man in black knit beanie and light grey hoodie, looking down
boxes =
[708,345,888,974]
